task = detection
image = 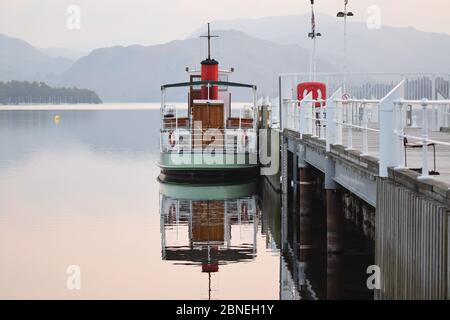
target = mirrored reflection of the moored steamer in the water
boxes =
[160,182,260,298]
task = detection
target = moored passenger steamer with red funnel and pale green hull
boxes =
[159,24,258,177]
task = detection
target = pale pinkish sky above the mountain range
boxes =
[0,0,450,51]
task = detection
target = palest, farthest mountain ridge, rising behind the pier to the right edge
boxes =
[192,14,450,73]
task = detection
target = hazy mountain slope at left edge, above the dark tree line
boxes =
[0,34,73,80]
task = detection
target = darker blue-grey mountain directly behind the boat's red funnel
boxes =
[57,31,333,102]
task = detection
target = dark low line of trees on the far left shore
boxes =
[0,81,102,104]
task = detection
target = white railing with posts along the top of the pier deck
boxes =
[280,74,450,179]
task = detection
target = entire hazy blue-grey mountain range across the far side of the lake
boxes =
[0,14,450,102]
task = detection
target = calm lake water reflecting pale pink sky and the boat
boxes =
[0,107,370,299]
